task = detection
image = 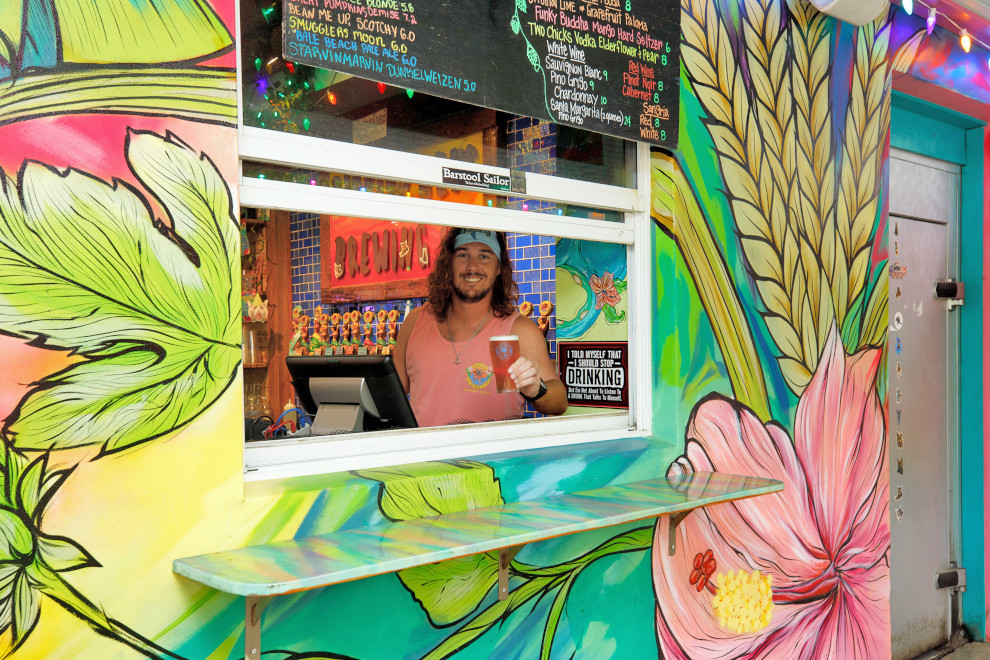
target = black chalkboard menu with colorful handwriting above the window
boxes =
[282,0,680,149]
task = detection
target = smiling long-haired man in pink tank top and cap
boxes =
[394,229,567,426]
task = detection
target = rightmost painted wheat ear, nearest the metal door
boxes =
[825,12,891,326]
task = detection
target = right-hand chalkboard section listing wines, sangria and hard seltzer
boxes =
[517,0,678,145]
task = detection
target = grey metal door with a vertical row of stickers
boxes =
[887,150,959,660]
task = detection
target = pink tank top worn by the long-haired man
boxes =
[406,304,524,426]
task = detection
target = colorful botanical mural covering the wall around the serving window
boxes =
[0,0,960,660]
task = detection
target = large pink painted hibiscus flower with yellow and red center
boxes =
[653,328,890,660]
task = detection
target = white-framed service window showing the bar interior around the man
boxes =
[239,2,649,478]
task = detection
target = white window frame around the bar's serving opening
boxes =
[237,11,653,481]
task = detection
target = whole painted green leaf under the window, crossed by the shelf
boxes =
[355,461,503,626]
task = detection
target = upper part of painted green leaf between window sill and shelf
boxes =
[354,461,503,520]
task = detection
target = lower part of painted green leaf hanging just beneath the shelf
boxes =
[399,552,498,627]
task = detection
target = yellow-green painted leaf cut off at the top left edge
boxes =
[54,0,234,64]
